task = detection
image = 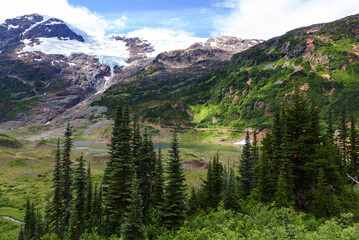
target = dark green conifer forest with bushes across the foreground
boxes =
[18,87,359,240]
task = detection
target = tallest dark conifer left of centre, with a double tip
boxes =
[104,102,134,235]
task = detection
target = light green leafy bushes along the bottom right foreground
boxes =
[159,205,359,240]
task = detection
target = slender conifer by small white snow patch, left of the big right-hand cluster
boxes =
[238,131,254,197]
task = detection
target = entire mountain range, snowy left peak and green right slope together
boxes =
[0,14,359,128]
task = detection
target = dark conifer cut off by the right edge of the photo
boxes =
[349,113,359,178]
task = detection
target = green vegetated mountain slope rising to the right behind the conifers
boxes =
[95,15,359,129]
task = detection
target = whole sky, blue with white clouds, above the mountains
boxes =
[0,0,359,40]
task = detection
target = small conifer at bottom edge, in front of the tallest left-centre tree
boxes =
[121,174,145,240]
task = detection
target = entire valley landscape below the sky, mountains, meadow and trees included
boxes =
[0,10,359,240]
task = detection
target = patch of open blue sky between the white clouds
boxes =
[68,0,230,37]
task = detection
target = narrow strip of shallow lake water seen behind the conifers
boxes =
[73,141,242,152]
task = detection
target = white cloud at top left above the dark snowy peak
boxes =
[0,0,126,37]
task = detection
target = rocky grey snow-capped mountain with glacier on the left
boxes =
[0,14,260,122]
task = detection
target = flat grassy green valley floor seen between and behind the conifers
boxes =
[0,126,245,239]
